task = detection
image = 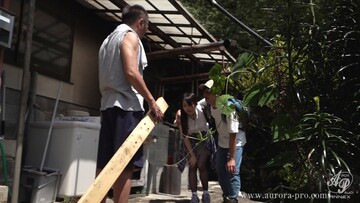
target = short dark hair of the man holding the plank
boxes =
[122,4,148,25]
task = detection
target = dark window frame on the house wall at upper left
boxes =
[4,0,75,82]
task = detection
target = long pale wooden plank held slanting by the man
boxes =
[78,97,168,203]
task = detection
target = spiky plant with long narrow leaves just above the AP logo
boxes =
[293,112,356,172]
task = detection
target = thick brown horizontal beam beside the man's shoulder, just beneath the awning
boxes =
[146,39,236,60]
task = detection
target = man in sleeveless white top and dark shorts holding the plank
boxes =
[97,5,163,203]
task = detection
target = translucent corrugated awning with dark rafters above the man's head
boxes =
[77,0,235,63]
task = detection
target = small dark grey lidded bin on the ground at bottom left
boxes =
[20,167,61,203]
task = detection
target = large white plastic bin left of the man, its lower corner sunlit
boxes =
[24,121,100,197]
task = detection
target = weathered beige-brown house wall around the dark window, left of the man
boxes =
[4,0,111,139]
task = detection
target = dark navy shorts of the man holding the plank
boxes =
[97,107,144,169]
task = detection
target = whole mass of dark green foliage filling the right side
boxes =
[182,0,360,195]
